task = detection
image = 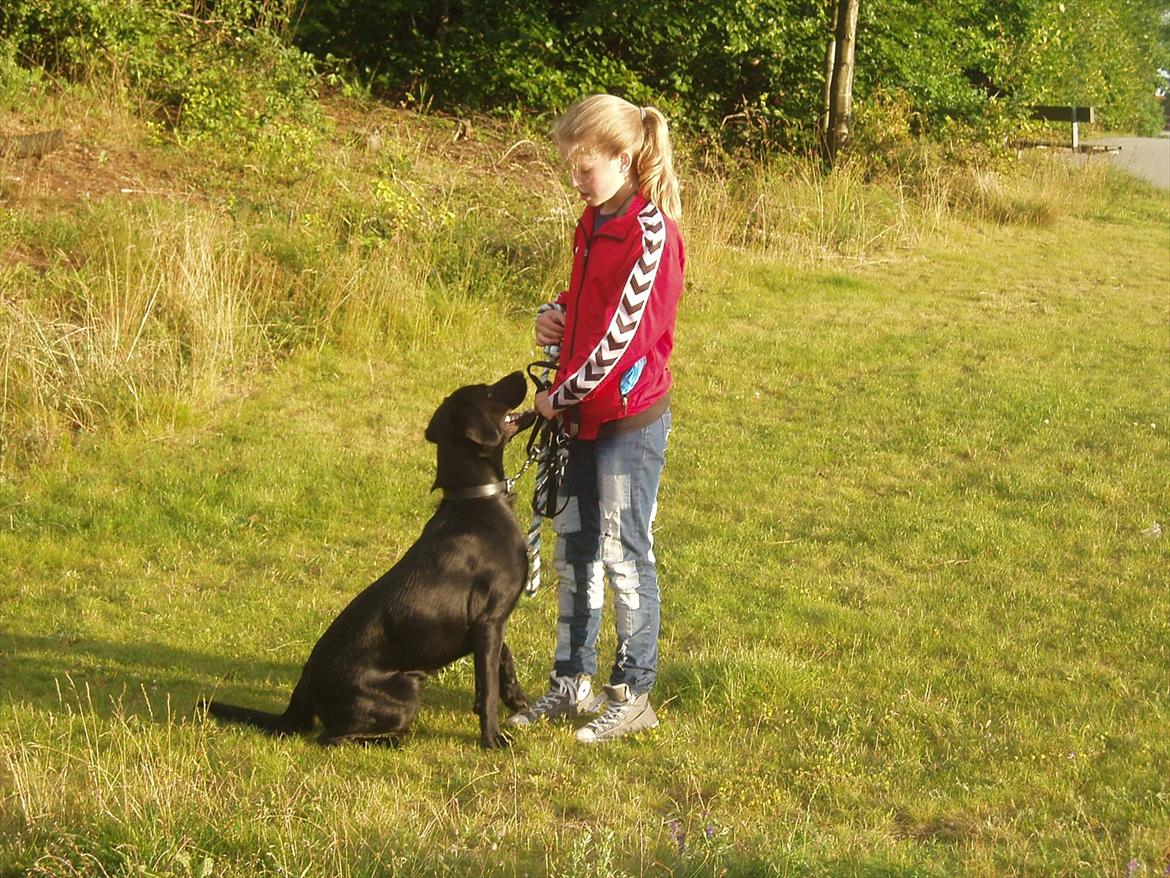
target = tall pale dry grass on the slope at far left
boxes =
[0,207,273,451]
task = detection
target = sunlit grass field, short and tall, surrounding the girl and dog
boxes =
[0,84,1170,878]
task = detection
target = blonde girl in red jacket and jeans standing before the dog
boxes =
[508,95,684,743]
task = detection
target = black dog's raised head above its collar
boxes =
[426,372,536,457]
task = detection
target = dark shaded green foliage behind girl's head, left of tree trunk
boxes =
[298,0,823,144]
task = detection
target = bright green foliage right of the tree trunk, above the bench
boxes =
[858,0,1170,143]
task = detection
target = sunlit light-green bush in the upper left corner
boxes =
[0,0,321,157]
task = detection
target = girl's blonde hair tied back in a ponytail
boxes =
[552,95,682,221]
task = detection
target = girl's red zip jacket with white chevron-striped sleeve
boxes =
[549,193,686,439]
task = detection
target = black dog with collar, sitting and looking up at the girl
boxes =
[206,372,532,747]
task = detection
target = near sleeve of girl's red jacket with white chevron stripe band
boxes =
[549,204,681,411]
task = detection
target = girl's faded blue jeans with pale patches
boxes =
[553,411,670,695]
